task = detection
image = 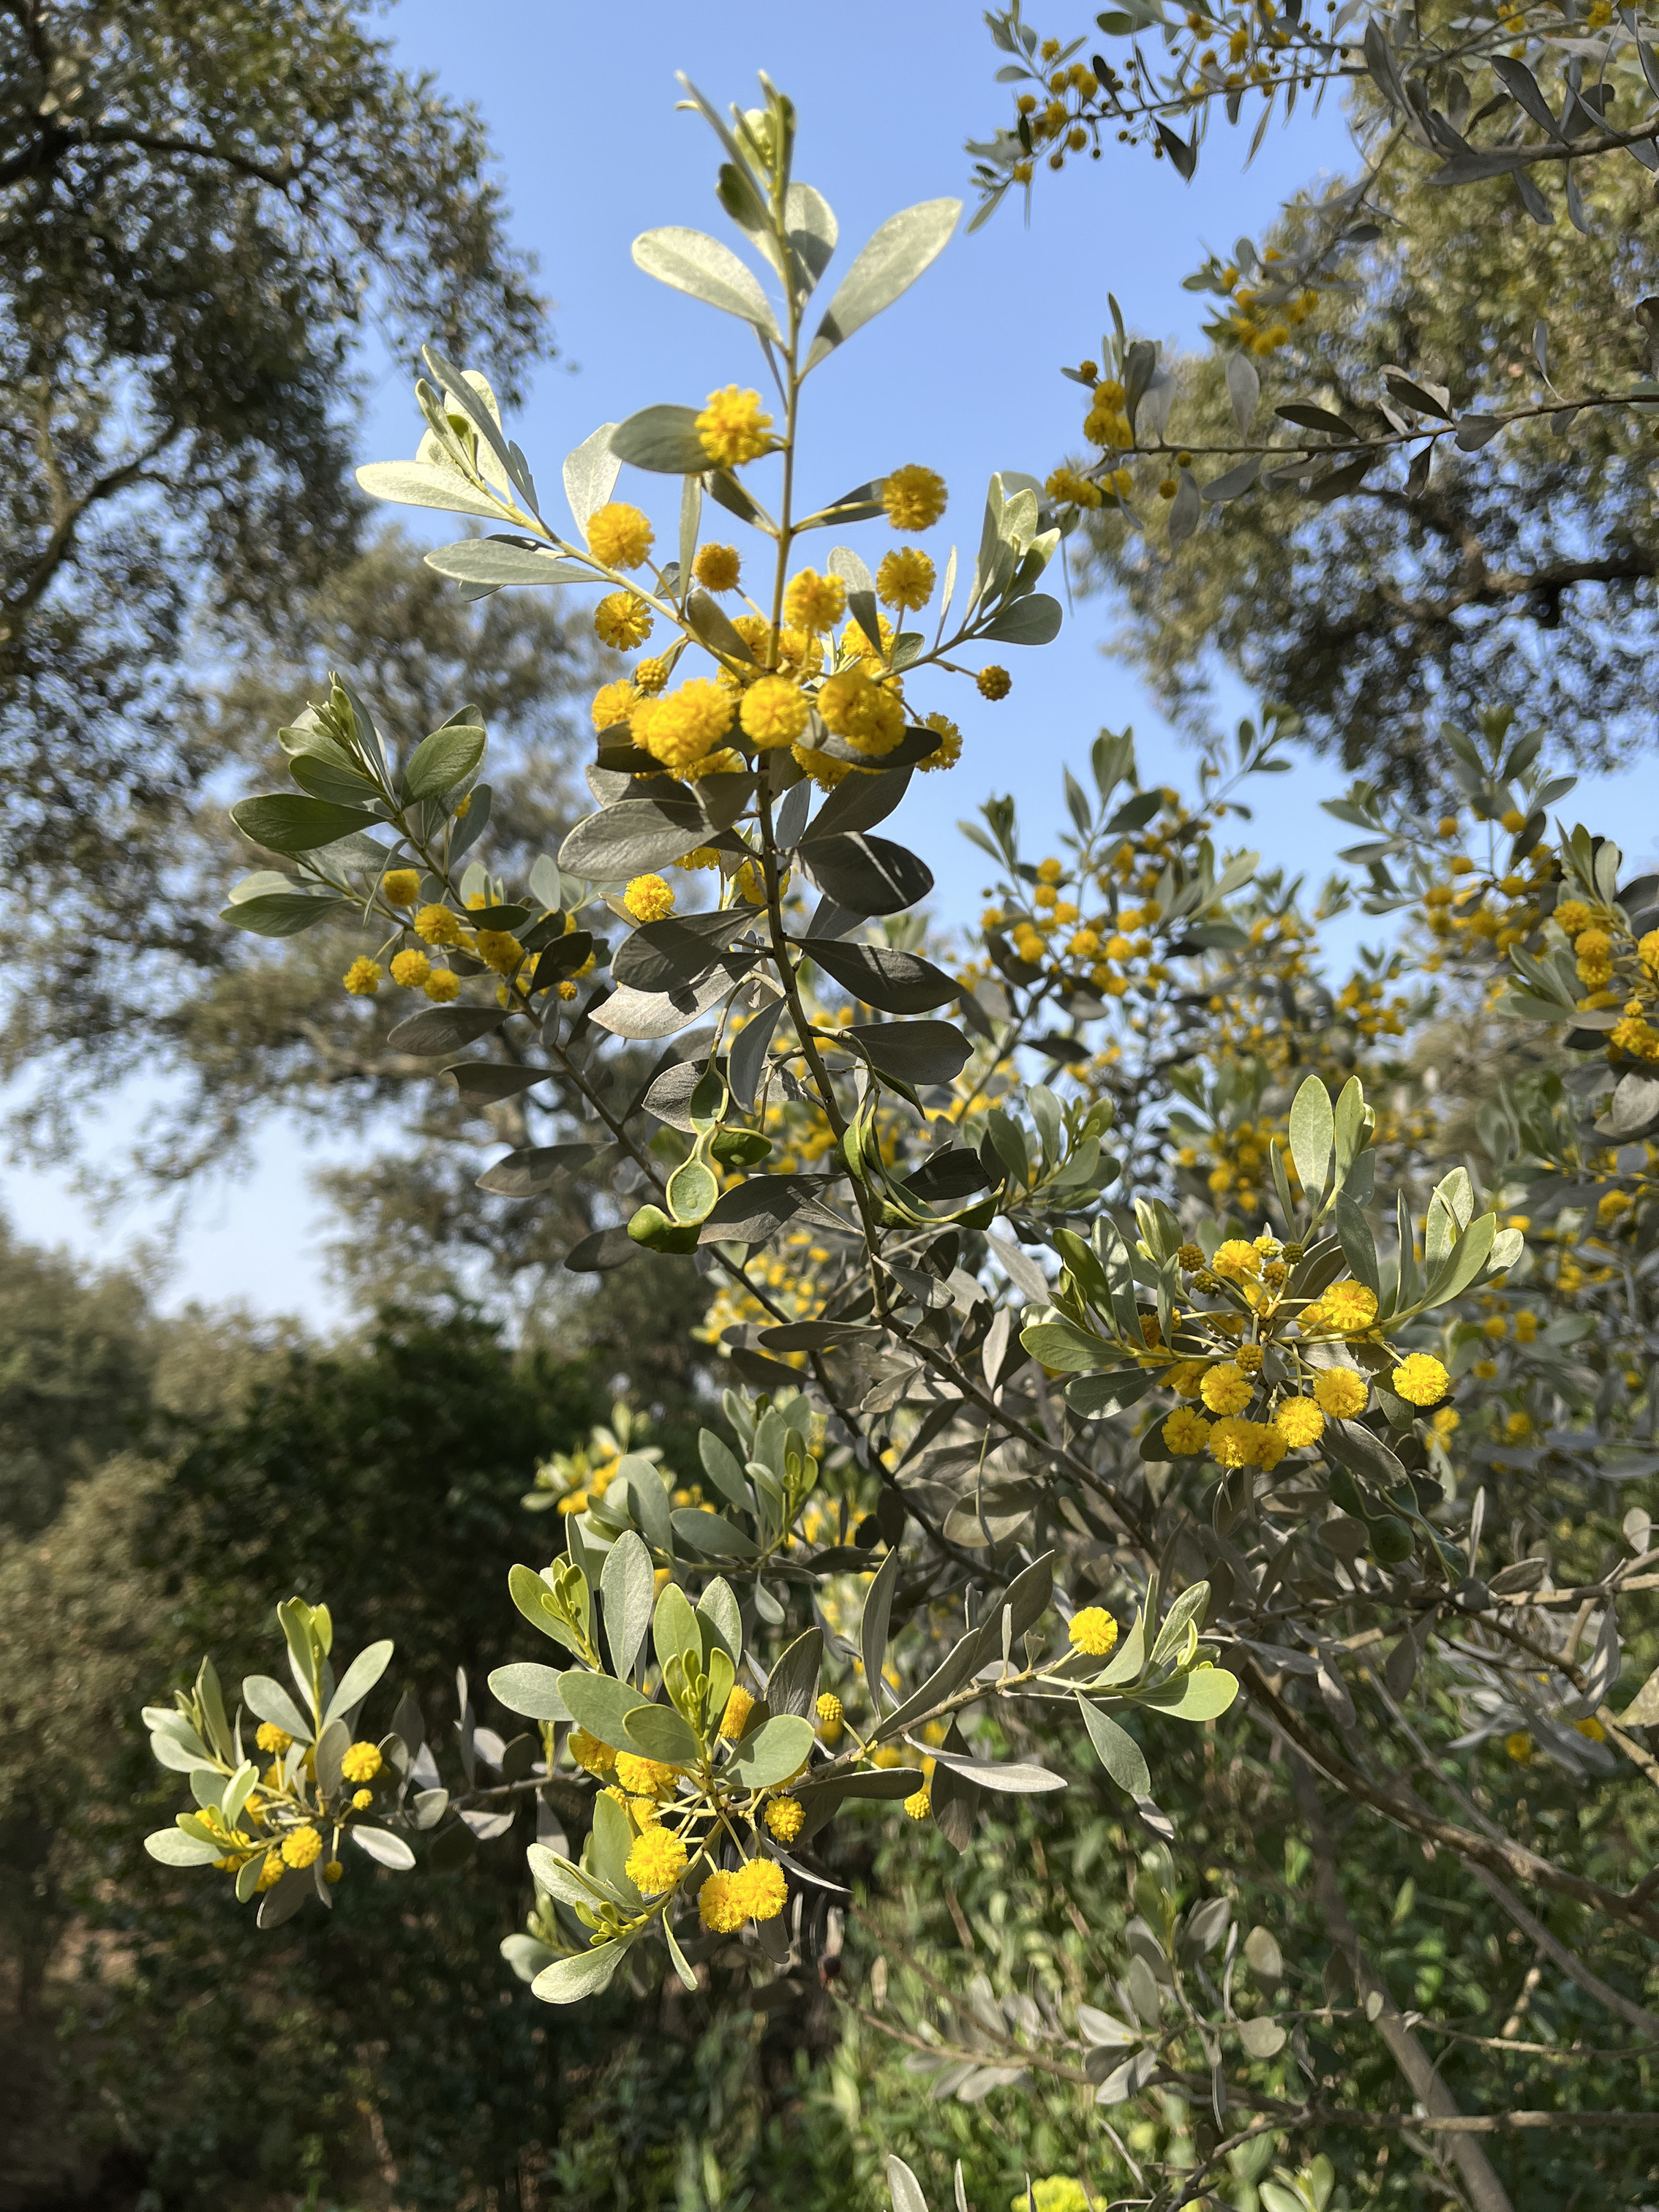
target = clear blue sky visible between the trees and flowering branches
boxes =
[12,0,1659,1323]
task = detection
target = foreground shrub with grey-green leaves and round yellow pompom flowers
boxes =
[136,69,1659,2203]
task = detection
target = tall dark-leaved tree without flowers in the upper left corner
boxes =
[0,0,546,1088]
